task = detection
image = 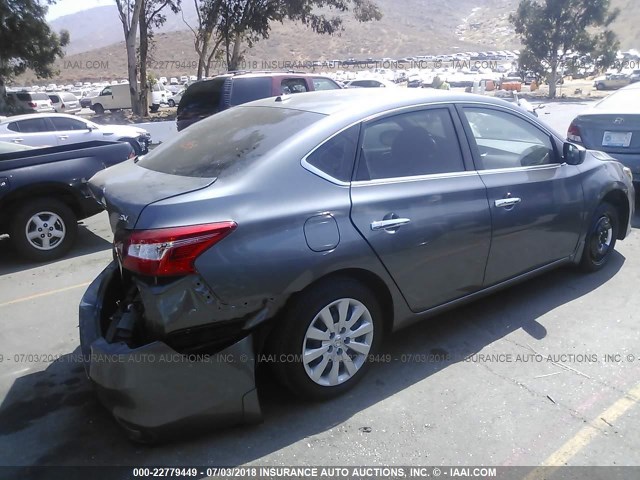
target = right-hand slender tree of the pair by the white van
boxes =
[137,0,180,116]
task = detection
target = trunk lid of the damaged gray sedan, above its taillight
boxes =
[89,160,216,234]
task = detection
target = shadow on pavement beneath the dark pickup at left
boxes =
[0,223,111,275]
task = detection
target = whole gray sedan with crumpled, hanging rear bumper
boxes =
[80,89,634,441]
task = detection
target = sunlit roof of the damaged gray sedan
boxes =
[244,88,519,118]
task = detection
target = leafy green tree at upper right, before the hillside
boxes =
[509,0,619,98]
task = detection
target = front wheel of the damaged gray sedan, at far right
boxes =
[580,202,620,272]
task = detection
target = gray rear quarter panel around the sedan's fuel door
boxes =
[136,123,410,326]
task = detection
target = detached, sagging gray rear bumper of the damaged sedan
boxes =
[80,263,261,441]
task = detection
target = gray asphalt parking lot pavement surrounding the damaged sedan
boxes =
[0,102,640,472]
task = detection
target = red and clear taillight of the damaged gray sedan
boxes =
[122,222,238,277]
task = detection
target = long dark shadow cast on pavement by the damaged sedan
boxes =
[0,252,625,466]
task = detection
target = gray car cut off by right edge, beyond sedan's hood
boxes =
[567,83,640,182]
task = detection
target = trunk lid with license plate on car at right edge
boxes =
[575,113,640,153]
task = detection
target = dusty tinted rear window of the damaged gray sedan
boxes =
[138,107,323,178]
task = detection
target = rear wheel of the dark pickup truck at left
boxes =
[9,198,78,262]
